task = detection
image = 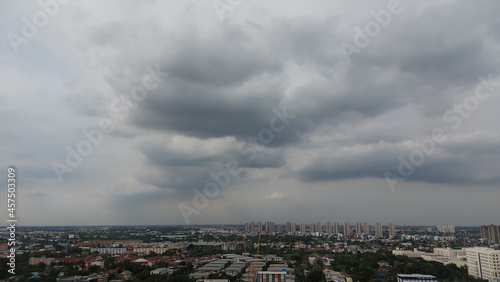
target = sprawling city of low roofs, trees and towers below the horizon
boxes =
[0,224,500,282]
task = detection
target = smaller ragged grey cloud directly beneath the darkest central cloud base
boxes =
[138,138,286,195]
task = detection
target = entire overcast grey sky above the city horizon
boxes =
[0,0,500,226]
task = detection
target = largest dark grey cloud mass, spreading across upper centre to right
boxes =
[114,4,500,146]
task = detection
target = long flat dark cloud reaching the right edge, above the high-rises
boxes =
[297,135,500,185]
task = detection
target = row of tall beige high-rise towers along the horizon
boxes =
[245,221,396,238]
